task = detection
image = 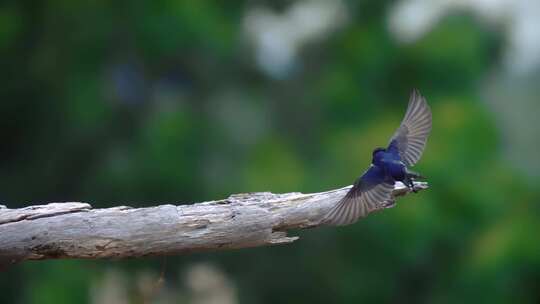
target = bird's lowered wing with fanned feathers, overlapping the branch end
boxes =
[324,165,394,226]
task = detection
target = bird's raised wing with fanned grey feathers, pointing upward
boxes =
[388,89,431,167]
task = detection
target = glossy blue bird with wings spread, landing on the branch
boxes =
[324,90,431,226]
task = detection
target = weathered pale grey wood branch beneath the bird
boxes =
[0,182,427,265]
